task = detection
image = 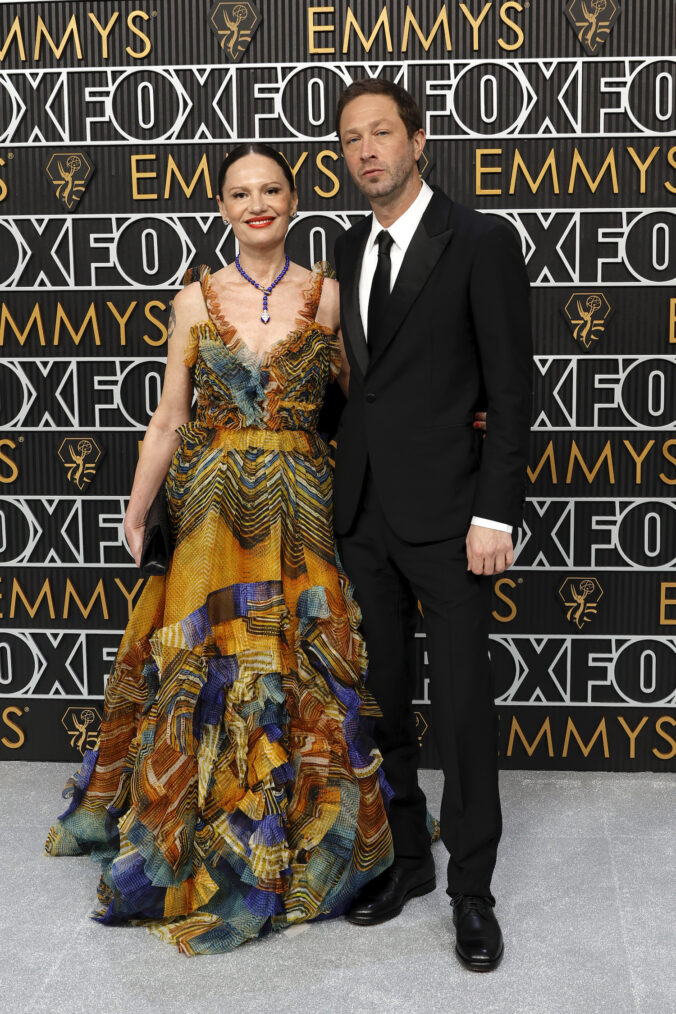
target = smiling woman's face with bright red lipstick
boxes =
[218,154,298,246]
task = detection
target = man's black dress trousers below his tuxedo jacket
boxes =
[339,469,502,897]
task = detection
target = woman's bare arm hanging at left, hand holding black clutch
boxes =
[125,283,205,566]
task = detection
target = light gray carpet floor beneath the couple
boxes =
[0,762,676,1014]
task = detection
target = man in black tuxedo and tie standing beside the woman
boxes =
[334,80,532,971]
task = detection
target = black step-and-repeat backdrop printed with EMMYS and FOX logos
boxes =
[0,0,676,771]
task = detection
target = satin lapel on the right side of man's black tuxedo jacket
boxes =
[369,192,453,366]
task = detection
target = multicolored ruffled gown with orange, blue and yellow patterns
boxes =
[47,266,392,954]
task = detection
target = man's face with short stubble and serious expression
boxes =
[341,95,425,201]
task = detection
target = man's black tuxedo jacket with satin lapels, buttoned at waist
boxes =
[334,188,532,542]
